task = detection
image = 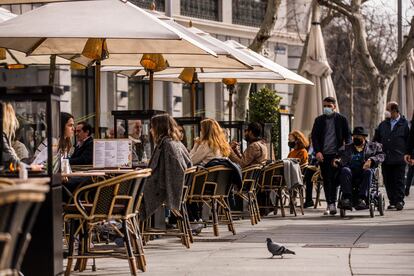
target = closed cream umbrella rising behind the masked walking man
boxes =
[293,8,336,135]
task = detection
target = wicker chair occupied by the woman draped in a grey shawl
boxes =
[143,167,198,248]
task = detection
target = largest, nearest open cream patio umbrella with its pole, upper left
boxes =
[0,0,233,134]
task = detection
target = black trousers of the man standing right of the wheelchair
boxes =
[382,164,405,205]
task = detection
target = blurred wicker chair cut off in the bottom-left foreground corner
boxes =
[0,182,49,275]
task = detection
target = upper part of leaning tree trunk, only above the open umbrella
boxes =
[249,0,281,52]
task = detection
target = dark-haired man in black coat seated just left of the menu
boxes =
[69,122,93,165]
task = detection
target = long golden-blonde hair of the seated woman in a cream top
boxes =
[199,119,231,157]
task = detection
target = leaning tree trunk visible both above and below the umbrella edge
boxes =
[235,0,281,120]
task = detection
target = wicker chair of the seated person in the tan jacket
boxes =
[232,165,263,225]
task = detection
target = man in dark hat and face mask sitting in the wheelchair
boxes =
[333,127,385,210]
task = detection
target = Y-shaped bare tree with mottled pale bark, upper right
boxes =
[318,0,414,133]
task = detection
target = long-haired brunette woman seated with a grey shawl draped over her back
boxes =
[143,114,191,219]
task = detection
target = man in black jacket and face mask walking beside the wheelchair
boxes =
[312,97,351,215]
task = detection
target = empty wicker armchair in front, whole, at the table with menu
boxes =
[64,169,151,275]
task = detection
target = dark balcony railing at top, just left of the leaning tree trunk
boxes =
[233,0,267,27]
